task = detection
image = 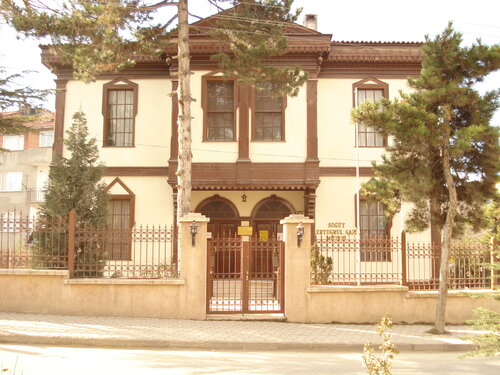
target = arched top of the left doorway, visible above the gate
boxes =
[196,195,240,237]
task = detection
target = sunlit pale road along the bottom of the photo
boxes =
[0,344,500,375]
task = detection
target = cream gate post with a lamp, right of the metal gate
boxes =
[280,215,314,322]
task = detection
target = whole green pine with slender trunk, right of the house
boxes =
[353,23,500,332]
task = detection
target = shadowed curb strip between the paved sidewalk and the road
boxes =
[0,335,474,352]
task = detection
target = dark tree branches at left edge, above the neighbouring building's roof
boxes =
[0,67,50,134]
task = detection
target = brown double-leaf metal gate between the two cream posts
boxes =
[207,236,285,314]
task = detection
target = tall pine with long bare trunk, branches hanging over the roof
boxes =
[0,0,306,218]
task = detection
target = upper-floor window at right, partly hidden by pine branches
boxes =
[353,78,389,147]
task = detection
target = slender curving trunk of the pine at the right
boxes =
[434,105,457,333]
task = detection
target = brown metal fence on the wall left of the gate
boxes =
[0,213,179,279]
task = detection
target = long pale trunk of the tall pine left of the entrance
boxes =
[176,0,192,220]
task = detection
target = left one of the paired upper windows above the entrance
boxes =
[203,79,236,142]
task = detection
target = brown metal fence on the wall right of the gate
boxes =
[311,232,496,290]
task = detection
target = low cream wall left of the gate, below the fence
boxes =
[0,270,199,319]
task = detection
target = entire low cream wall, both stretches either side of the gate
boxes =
[0,270,500,324]
